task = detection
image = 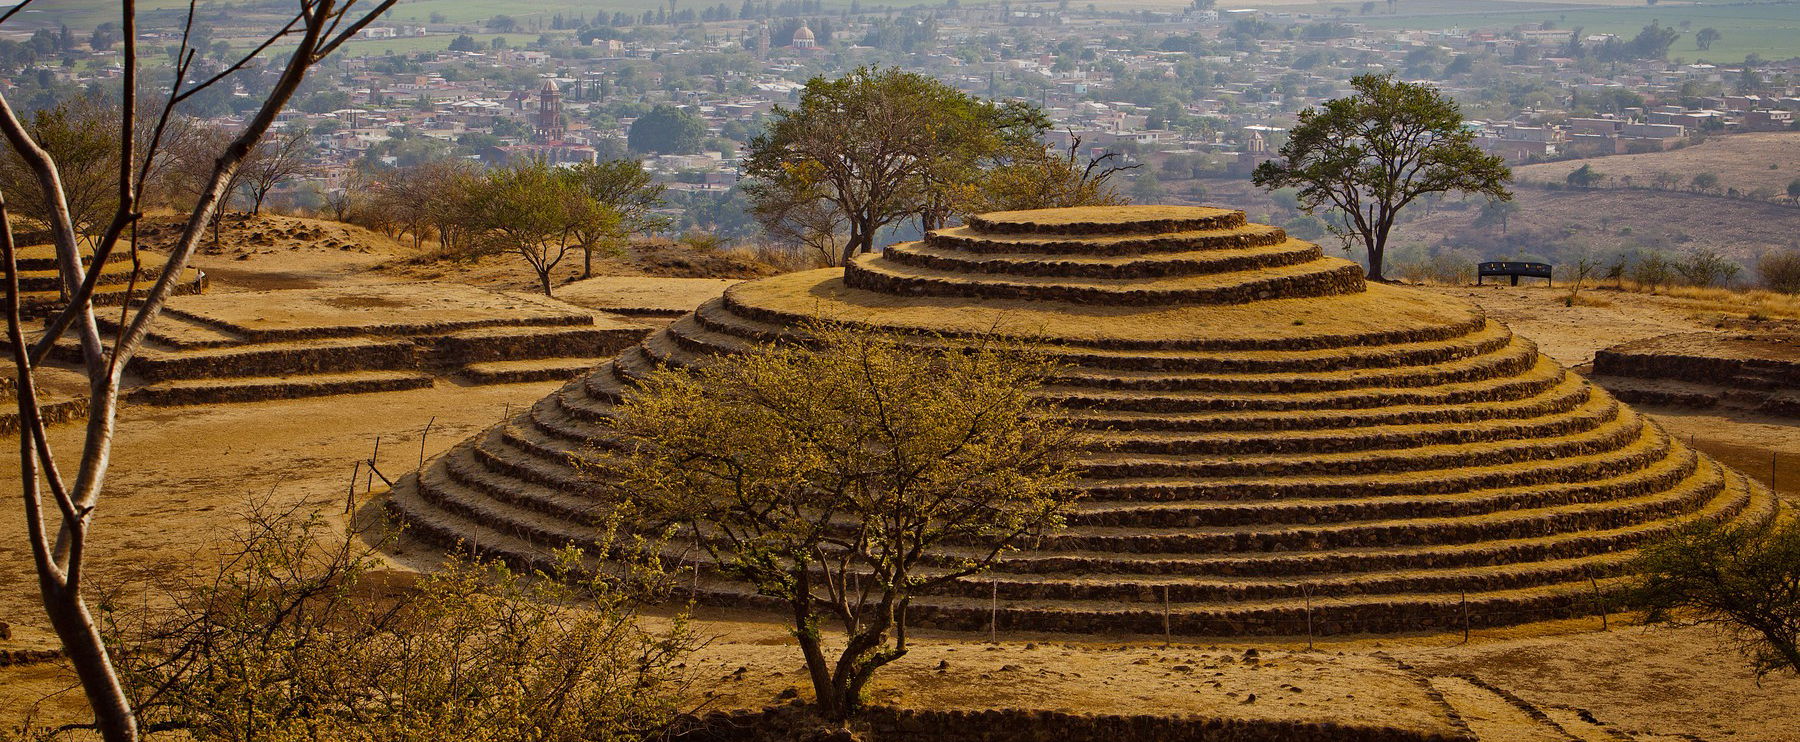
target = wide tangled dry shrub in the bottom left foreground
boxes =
[87,508,695,742]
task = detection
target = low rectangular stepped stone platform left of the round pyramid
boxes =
[26,283,652,405]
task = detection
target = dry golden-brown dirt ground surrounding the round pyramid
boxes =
[0,217,1800,742]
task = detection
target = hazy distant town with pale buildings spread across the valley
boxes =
[0,0,1800,236]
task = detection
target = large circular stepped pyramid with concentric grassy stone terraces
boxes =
[389,207,1777,636]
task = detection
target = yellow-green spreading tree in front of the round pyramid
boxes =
[596,326,1078,719]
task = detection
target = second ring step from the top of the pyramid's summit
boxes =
[925,223,1287,256]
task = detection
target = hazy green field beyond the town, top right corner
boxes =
[1352,0,1800,61]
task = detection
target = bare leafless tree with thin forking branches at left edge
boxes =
[0,0,396,742]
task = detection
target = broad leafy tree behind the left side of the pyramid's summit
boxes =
[743,67,1049,261]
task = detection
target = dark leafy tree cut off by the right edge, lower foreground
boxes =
[1634,517,1800,677]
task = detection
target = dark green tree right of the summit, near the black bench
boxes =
[1251,74,1512,281]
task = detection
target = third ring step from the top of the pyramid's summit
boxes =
[882,240,1323,279]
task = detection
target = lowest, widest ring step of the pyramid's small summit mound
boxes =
[844,254,1363,306]
